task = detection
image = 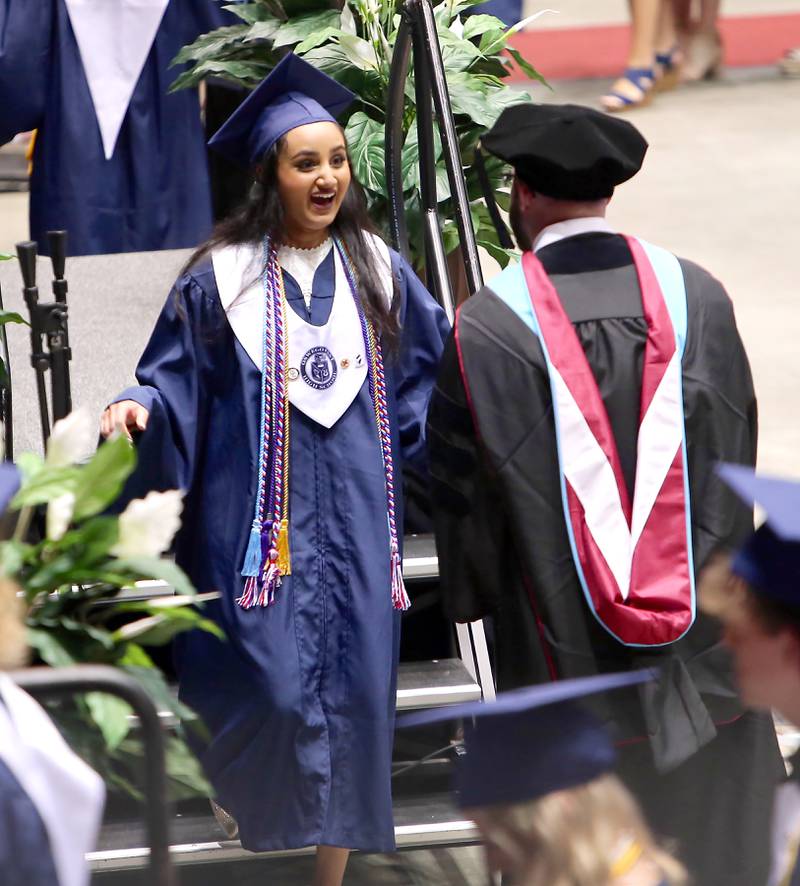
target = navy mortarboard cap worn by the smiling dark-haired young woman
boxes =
[208,53,355,166]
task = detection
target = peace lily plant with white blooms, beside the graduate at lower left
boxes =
[0,410,222,799]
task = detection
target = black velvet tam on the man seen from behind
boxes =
[481,102,647,200]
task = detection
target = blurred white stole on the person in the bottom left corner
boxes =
[0,674,105,886]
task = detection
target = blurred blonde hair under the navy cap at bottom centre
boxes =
[468,775,687,886]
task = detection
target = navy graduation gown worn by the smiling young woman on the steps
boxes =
[113,245,447,851]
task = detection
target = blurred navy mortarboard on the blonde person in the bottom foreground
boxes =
[398,670,653,808]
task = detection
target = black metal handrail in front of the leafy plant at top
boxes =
[386,0,483,322]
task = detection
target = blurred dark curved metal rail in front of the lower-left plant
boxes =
[10,665,175,886]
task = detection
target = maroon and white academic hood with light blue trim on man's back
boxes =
[492,237,695,646]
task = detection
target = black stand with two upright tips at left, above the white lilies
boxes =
[17,231,72,446]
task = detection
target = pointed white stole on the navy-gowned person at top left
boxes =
[65,0,169,160]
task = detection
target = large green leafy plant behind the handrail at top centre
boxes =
[172,0,545,268]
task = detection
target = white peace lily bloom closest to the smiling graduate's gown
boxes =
[111,489,183,557]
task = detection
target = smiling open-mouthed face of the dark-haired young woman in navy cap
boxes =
[277,121,350,248]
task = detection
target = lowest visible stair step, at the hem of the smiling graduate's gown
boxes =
[87,793,478,872]
